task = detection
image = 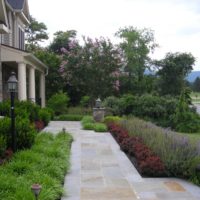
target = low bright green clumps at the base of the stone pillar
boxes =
[81,116,107,132]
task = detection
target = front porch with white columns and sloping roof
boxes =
[0,45,48,107]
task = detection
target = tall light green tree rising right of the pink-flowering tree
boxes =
[116,27,157,92]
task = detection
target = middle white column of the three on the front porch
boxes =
[29,67,35,103]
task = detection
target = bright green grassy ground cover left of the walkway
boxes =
[0,132,72,200]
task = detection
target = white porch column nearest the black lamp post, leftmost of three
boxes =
[18,63,27,101]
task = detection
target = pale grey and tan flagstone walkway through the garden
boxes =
[45,121,200,200]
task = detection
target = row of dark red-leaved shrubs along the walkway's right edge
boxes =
[108,124,165,176]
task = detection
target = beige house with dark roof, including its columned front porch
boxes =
[0,0,48,107]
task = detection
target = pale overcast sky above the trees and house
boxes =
[29,0,200,71]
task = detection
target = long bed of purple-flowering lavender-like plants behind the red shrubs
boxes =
[121,117,198,178]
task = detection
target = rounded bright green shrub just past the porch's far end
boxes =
[48,92,69,115]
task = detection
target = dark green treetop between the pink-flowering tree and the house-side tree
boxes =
[49,30,76,54]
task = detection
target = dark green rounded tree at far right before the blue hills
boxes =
[155,53,195,96]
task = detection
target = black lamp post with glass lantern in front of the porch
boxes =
[7,72,18,152]
